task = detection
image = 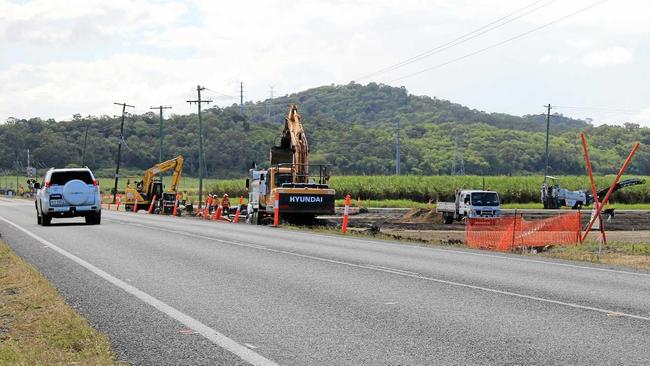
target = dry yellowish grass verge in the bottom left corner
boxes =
[0,242,121,365]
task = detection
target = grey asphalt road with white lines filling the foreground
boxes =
[0,200,650,365]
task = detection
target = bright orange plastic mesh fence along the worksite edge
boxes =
[465,212,581,252]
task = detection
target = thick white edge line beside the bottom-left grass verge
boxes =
[0,216,277,366]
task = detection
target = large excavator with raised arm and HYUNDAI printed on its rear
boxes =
[246,105,336,225]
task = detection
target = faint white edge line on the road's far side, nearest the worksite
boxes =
[102,216,650,277]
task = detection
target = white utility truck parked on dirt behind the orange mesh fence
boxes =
[436,190,501,224]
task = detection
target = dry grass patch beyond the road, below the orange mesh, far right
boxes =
[541,240,650,270]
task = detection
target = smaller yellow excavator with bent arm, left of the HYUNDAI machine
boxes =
[124,155,183,213]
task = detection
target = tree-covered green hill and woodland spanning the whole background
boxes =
[0,83,650,177]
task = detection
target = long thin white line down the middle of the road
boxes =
[115,217,650,321]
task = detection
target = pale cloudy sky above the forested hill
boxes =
[0,0,650,126]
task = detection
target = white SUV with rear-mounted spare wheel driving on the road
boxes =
[34,168,102,226]
